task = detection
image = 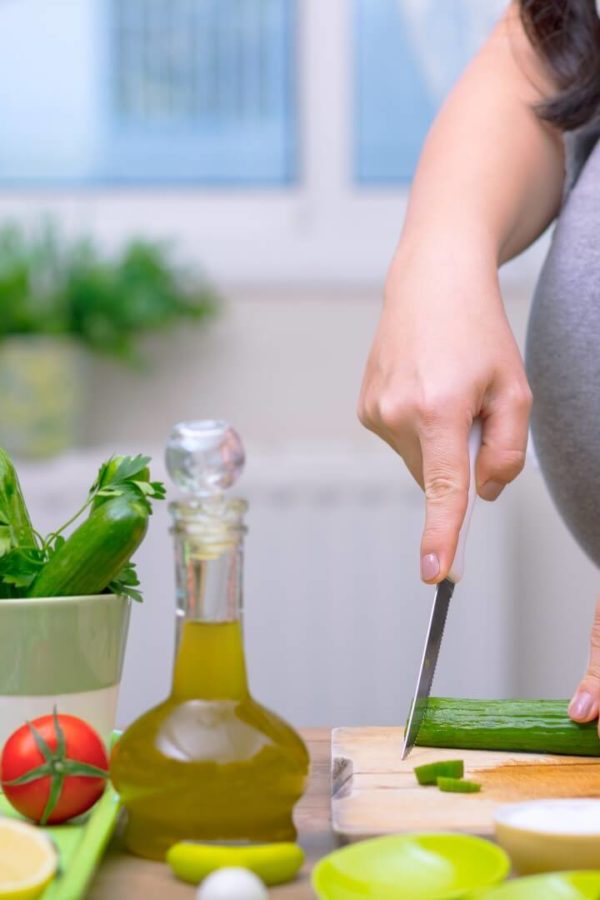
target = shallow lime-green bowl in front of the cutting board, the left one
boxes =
[312,834,510,900]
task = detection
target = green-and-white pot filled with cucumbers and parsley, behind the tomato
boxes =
[0,448,165,749]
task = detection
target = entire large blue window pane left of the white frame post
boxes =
[0,0,297,184]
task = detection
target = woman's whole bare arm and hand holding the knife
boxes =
[359,5,563,582]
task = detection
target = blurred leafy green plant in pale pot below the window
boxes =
[0,222,218,457]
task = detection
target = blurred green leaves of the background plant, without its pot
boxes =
[0,219,220,365]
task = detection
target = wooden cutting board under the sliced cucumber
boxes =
[331,728,600,840]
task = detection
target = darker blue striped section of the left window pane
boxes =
[103,0,296,184]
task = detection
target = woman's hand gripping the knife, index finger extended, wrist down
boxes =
[358,241,531,583]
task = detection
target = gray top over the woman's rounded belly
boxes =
[525,126,600,565]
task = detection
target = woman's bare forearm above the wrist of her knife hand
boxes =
[401,6,564,266]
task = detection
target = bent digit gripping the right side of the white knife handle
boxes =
[477,377,531,500]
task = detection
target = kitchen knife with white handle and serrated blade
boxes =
[401,419,481,759]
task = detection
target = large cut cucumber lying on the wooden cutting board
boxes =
[416,697,600,756]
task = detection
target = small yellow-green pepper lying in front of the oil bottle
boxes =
[166,841,304,885]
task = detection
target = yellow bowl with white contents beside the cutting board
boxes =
[494,798,600,875]
